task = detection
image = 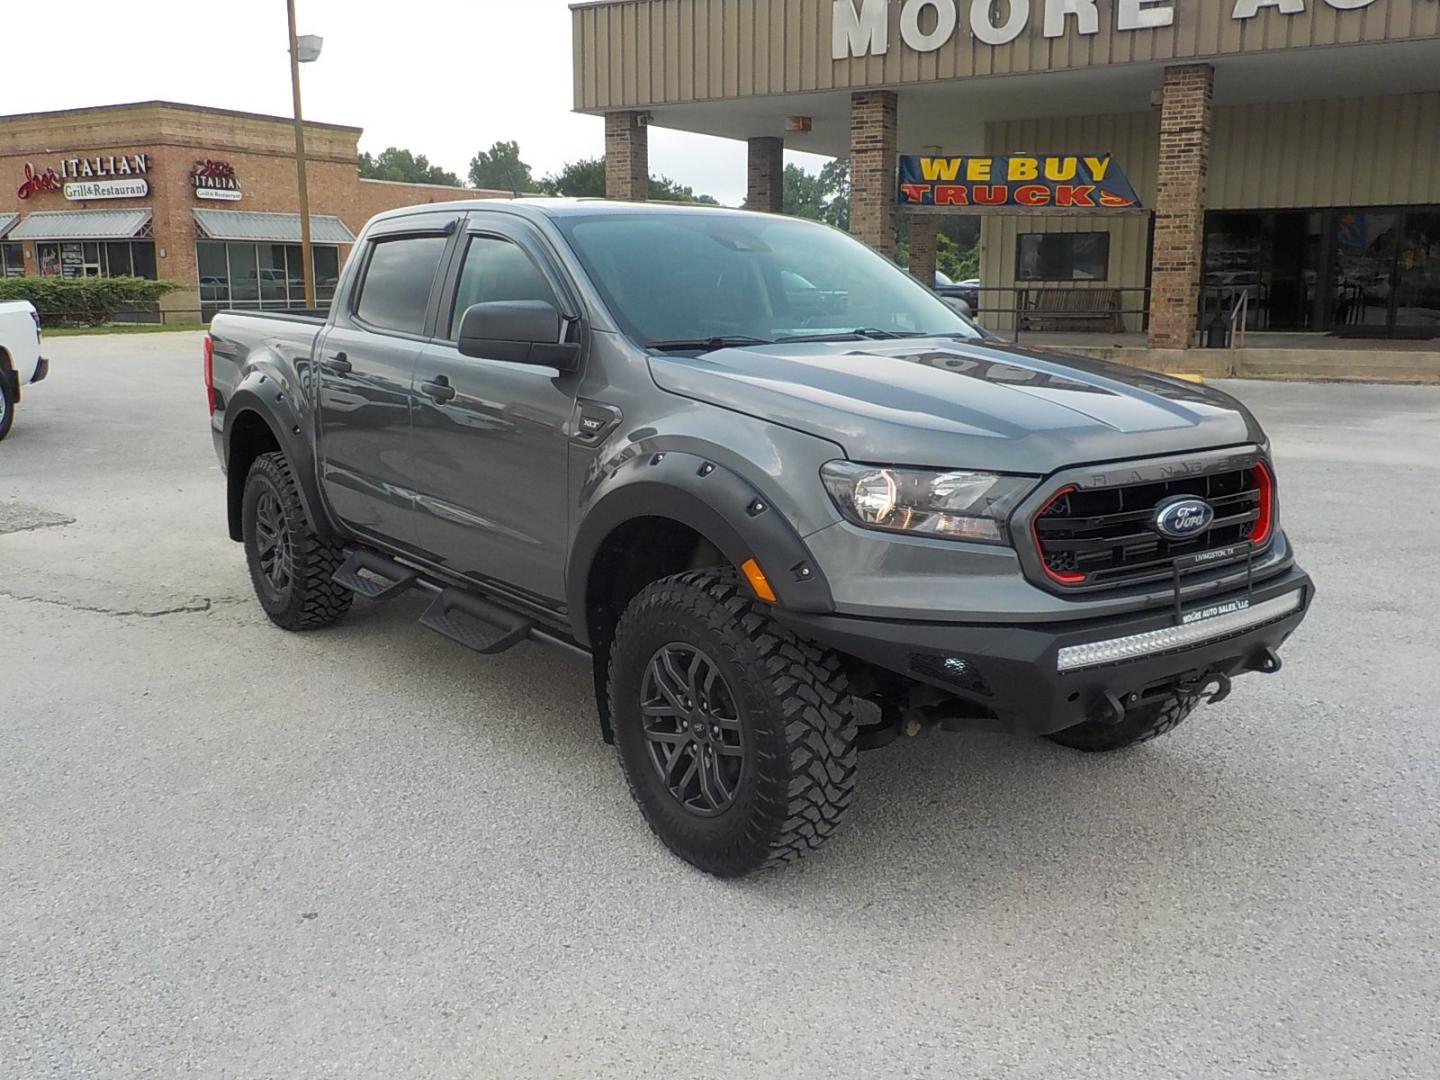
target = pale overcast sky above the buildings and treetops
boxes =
[0,0,822,203]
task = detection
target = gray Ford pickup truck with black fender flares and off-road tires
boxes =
[206,200,1313,876]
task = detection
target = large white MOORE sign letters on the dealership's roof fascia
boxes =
[831,0,1375,60]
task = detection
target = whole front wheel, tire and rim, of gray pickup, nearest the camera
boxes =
[609,570,857,877]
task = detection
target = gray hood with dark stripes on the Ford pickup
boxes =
[649,337,1264,475]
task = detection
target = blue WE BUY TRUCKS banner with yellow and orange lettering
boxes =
[900,154,1140,212]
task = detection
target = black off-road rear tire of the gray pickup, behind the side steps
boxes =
[240,454,354,631]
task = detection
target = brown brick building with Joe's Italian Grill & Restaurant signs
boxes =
[0,101,508,321]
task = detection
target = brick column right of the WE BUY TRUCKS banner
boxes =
[1149,63,1215,348]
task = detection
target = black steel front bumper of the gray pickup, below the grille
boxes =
[776,569,1315,734]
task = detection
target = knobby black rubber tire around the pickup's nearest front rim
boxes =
[609,570,857,877]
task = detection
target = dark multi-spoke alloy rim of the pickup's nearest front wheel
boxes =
[641,641,749,818]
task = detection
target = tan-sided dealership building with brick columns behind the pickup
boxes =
[573,0,1440,350]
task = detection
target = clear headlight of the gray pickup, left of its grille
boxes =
[819,461,1037,544]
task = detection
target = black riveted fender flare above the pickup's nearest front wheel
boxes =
[566,451,835,645]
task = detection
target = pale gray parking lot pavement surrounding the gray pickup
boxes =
[0,334,1440,1080]
